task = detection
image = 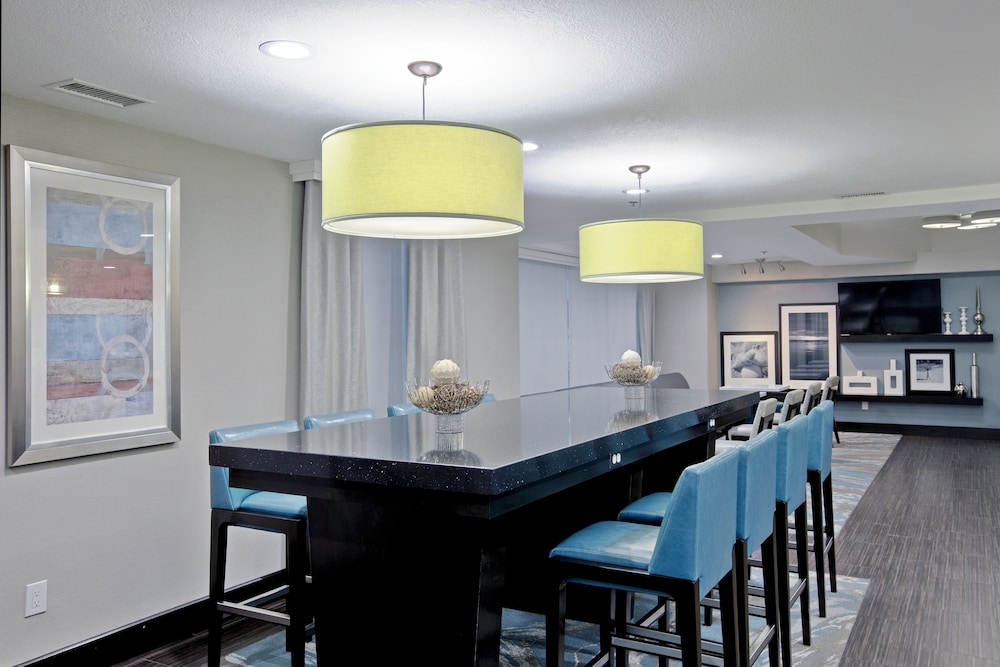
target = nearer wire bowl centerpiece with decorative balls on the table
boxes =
[406,359,490,433]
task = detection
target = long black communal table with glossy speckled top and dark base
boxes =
[209,386,759,666]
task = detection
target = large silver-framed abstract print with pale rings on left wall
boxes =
[4,145,181,467]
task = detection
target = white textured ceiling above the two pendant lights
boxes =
[2,0,1000,268]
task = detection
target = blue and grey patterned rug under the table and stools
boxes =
[223,433,899,667]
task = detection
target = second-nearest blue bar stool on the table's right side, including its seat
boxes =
[618,430,788,666]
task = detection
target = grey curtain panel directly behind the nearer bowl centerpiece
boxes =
[406,241,467,380]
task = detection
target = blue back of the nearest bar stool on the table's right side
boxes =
[649,448,740,597]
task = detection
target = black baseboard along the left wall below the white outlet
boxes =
[17,572,284,667]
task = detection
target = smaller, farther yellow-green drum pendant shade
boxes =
[580,218,705,283]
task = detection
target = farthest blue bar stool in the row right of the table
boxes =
[806,400,837,617]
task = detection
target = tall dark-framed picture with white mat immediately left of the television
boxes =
[778,303,840,389]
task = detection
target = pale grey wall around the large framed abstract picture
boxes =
[0,96,299,665]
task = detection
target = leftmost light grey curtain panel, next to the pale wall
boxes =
[299,181,369,417]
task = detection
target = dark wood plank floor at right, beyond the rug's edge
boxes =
[837,436,1000,667]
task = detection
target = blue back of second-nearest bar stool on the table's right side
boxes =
[736,430,778,556]
